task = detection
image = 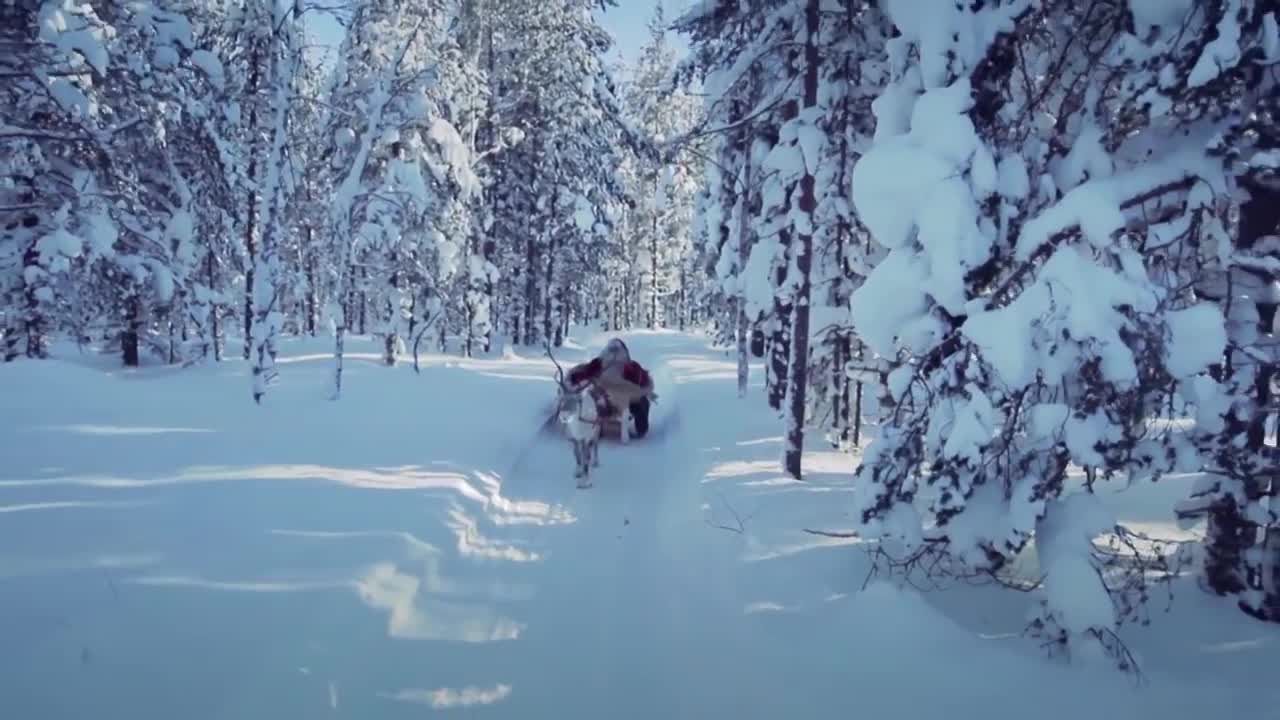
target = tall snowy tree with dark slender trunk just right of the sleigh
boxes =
[680,1,868,477]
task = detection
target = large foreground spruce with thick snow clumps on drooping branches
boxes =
[851,1,1274,665]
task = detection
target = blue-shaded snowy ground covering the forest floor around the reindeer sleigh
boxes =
[0,333,1280,720]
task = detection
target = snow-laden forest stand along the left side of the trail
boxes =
[3,0,703,396]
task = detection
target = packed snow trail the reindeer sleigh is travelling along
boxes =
[494,334,854,719]
